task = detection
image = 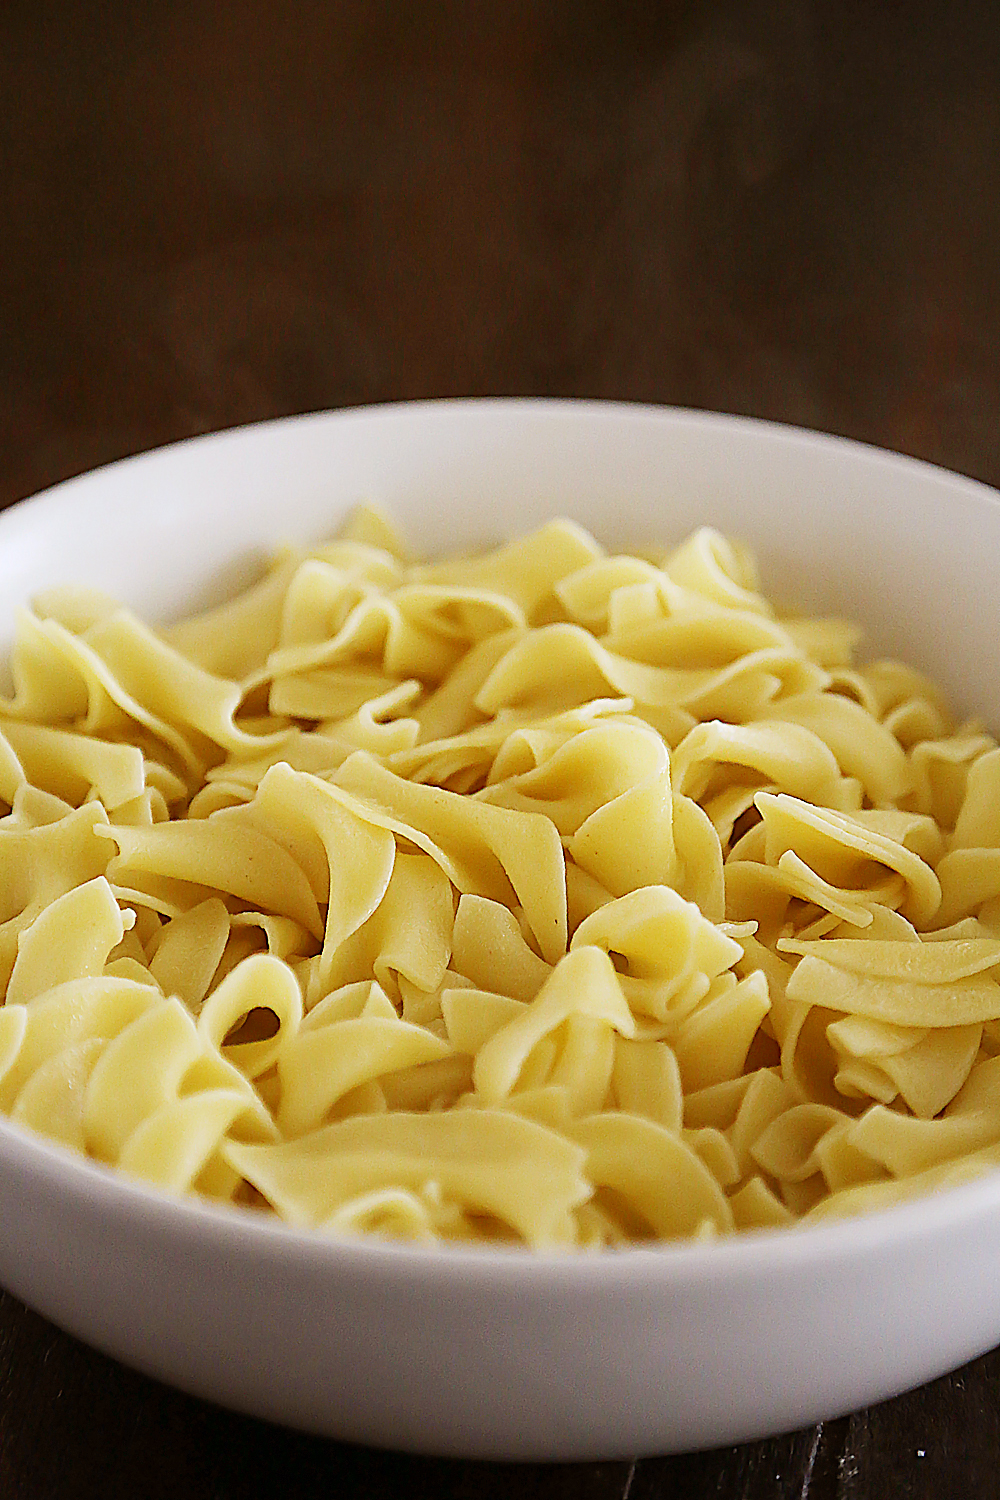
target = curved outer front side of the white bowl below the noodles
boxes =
[0,1125,1000,1460]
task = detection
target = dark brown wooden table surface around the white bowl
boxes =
[0,0,1000,1500]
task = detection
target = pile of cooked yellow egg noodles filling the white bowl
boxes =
[0,509,1000,1248]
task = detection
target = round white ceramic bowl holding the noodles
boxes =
[0,401,1000,1458]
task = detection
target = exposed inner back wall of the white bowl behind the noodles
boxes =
[0,401,1000,723]
